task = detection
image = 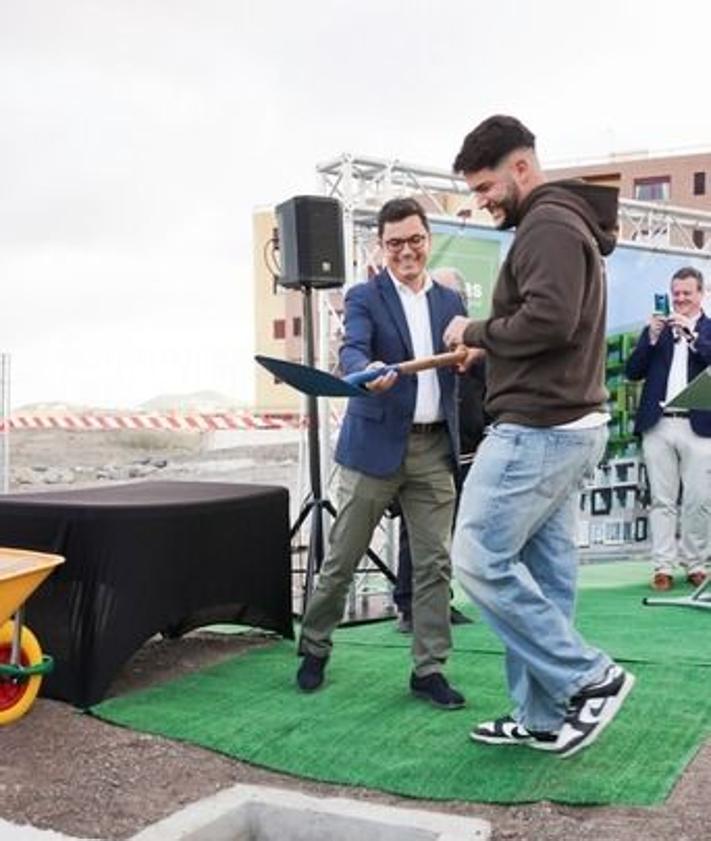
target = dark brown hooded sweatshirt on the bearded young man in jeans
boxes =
[464,181,617,426]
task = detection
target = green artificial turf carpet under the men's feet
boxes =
[92,565,711,805]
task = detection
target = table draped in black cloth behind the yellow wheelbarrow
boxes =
[0,482,293,707]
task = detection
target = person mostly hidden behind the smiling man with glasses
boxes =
[393,266,488,634]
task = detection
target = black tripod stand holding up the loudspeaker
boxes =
[290,284,396,621]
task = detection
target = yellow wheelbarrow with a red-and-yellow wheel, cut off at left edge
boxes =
[0,548,64,726]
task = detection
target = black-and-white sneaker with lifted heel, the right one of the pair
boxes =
[555,665,635,758]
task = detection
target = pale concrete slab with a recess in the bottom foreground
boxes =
[131,785,491,841]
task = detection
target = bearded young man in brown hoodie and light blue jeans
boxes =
[445,116,634,756]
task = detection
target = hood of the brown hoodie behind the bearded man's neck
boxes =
[516,178,619,257]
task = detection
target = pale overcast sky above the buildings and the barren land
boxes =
[0,0,711,407]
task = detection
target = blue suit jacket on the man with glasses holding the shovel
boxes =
[335,271,466,477]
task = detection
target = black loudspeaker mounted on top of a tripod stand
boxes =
[276,196,346,289]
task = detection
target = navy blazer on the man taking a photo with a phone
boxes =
[625,313,711,438]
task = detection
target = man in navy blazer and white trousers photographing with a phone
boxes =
[625,266,711,590]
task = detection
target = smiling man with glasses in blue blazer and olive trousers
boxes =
[297,199,475,709]
